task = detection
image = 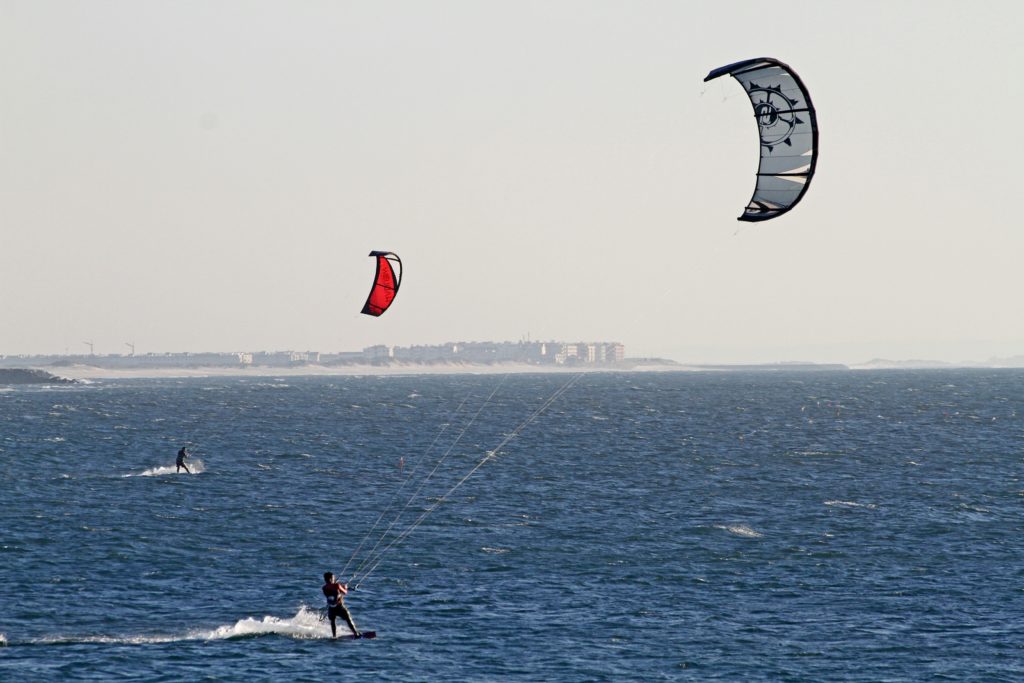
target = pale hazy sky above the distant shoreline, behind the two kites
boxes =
[0,0,1024,362]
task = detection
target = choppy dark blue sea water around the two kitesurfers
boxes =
[0,370,1024,682]
